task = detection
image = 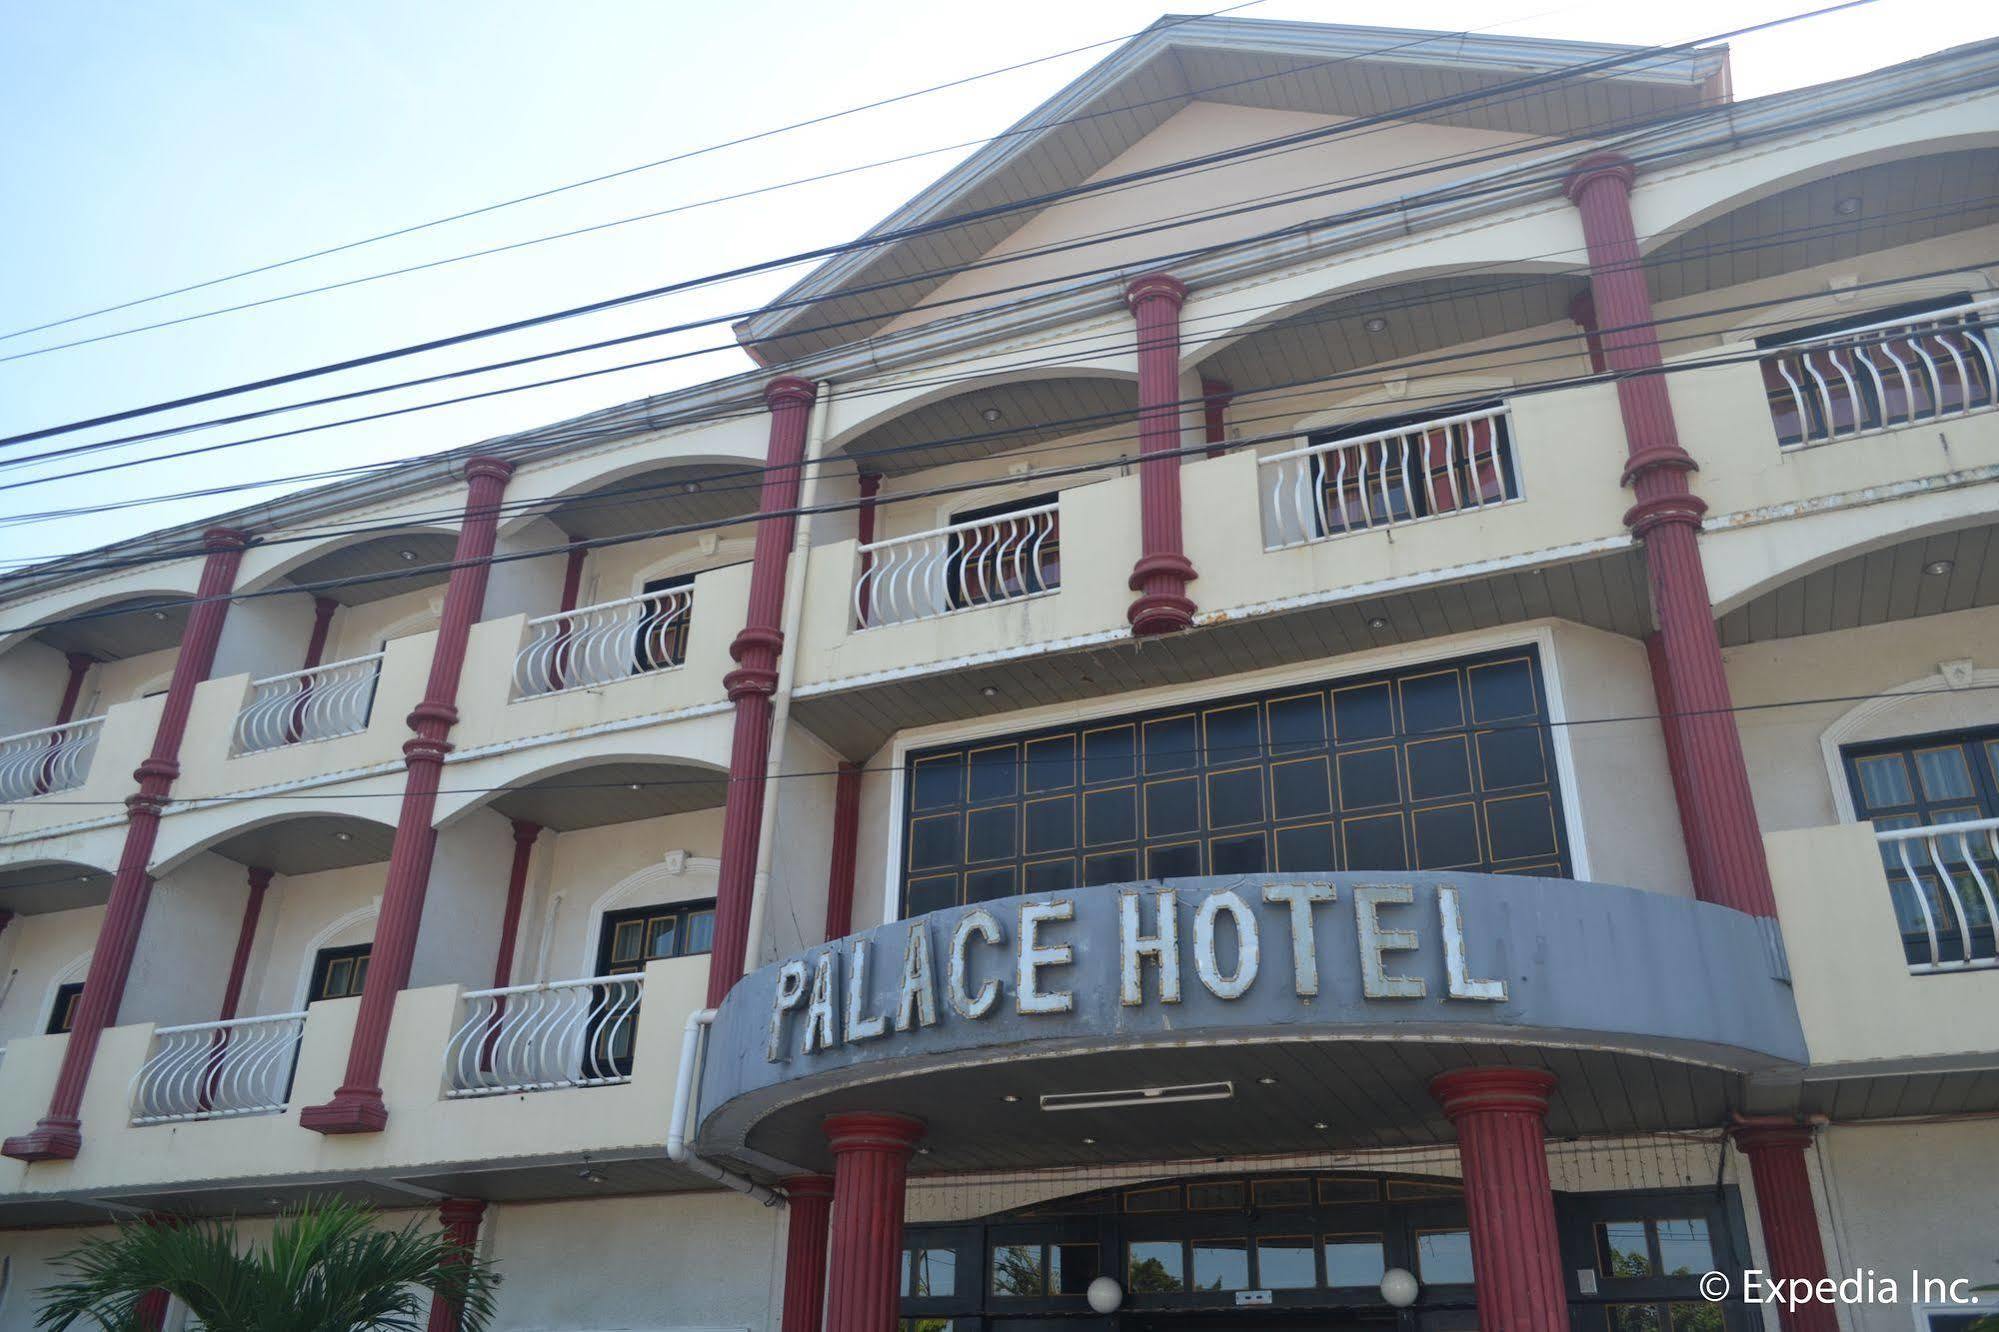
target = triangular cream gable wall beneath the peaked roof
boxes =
[888,102,1529,332]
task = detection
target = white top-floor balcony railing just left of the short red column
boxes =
[854,502,1061,628]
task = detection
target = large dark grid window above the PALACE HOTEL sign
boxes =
[902,648,1569,916]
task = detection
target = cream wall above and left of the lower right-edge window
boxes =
[1723,608,1999,832]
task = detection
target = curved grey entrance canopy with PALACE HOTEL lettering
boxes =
[698,872,1805,1170]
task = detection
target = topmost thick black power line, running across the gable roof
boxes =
[0,0,1875,446]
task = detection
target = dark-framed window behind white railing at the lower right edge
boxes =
[1841,726,1999,964]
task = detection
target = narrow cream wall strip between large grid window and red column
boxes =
[1553,624,1693,898]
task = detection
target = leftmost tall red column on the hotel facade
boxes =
[0,528,250,1160]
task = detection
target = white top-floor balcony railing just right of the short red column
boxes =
[1257,404,1519,550]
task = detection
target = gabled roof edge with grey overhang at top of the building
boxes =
[736,16,1729,364]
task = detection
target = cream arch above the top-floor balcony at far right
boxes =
[1631,132,1999,254]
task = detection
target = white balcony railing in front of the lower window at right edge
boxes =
[1875,818,1999,974]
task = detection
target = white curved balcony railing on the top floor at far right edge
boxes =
[1761,298,1999,448]
